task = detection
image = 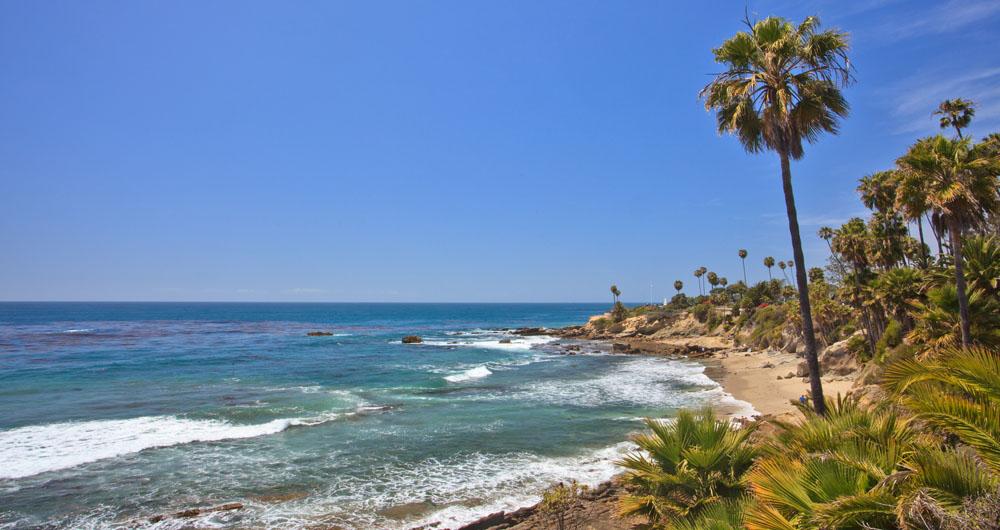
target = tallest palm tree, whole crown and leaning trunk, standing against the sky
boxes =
[701,17,851,413]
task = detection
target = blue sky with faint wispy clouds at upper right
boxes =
[0,0,1000,302]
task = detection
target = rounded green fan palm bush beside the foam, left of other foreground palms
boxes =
[618,409,758,524]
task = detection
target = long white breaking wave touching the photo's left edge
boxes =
[0,412,358,479]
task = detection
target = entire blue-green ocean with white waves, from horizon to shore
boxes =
[0,303,747,528]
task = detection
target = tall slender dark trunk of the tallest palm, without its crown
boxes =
[779,152,826,416]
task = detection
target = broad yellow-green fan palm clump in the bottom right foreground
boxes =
[745,396,997,530]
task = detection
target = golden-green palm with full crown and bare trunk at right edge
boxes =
[897,135,1000,346]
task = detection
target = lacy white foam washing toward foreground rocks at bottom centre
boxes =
[232,442,636,530]
